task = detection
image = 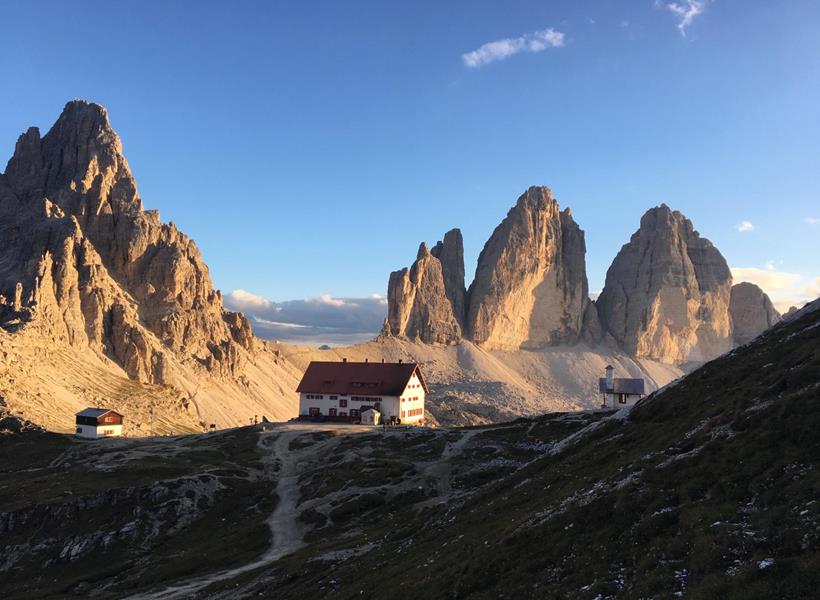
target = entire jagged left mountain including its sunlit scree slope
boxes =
[0,100,302,431]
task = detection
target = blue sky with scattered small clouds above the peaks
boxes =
[0,0,820,342]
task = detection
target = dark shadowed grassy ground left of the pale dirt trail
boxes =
[0,429,276,598]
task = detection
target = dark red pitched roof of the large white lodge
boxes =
[296,361,428,396]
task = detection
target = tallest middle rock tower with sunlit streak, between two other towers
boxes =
[466,187,589,350]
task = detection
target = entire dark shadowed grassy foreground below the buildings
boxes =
[0,304,820,600]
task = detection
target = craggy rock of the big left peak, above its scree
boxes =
[0,100,253,383]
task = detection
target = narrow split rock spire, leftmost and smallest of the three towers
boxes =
[385,237,464,344]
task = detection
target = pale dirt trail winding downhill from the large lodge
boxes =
[127,427,346,600]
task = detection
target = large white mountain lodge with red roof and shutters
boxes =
[296,360,427,425]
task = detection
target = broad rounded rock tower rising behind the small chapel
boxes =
[596,204,733,364]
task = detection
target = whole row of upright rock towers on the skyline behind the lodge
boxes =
[383,192,780,368]
